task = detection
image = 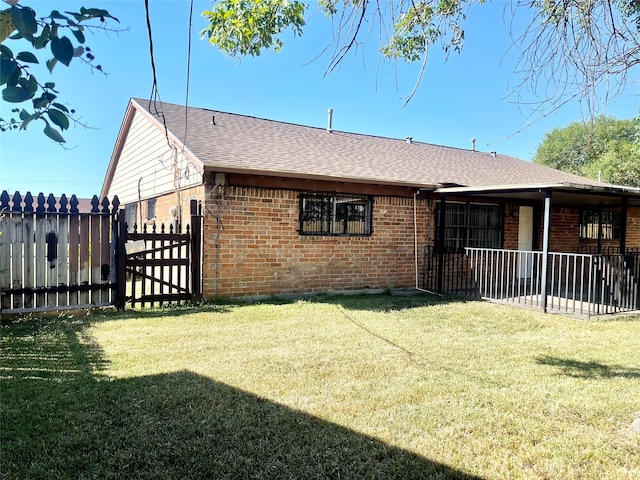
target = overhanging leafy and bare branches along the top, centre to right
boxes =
[203,0,640,108]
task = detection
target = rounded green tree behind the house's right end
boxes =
[533,116,640,187]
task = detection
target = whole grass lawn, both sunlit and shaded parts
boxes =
[0,295,640,479]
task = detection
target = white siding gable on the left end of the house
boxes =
[108,112,202,204]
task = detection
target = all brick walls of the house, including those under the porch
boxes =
[143,180,640,298]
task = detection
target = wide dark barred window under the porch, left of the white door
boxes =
[436,202,504,253]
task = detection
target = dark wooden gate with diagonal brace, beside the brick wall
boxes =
[116,202,202,309]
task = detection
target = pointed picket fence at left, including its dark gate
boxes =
[0,191,202,314]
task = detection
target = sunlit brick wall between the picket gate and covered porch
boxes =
[203,186,430,297]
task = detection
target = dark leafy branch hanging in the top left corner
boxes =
[0,2,118,143]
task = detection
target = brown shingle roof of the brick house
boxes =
[134,100,600,186]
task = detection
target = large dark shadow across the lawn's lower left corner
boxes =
[0,321,478,480]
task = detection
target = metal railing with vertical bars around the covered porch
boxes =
[423,247,640,316]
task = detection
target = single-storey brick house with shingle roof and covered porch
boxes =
[102,99,640,316]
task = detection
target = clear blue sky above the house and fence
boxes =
[0,0,639,197]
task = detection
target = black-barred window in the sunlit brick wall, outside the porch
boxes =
[300,194,373,236]
